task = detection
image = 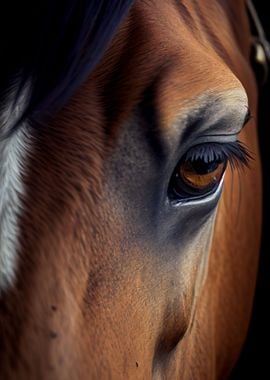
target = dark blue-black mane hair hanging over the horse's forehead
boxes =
[0,0,133,127]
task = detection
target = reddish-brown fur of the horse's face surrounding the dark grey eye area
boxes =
[0,0,261,380]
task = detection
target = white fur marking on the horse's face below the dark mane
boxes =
[0,91,29,293]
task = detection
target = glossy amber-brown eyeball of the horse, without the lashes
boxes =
[169,158,227,200]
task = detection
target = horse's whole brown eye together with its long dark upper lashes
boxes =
[168,141,251,201]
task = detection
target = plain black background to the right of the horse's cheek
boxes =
[230,0,270,380]
